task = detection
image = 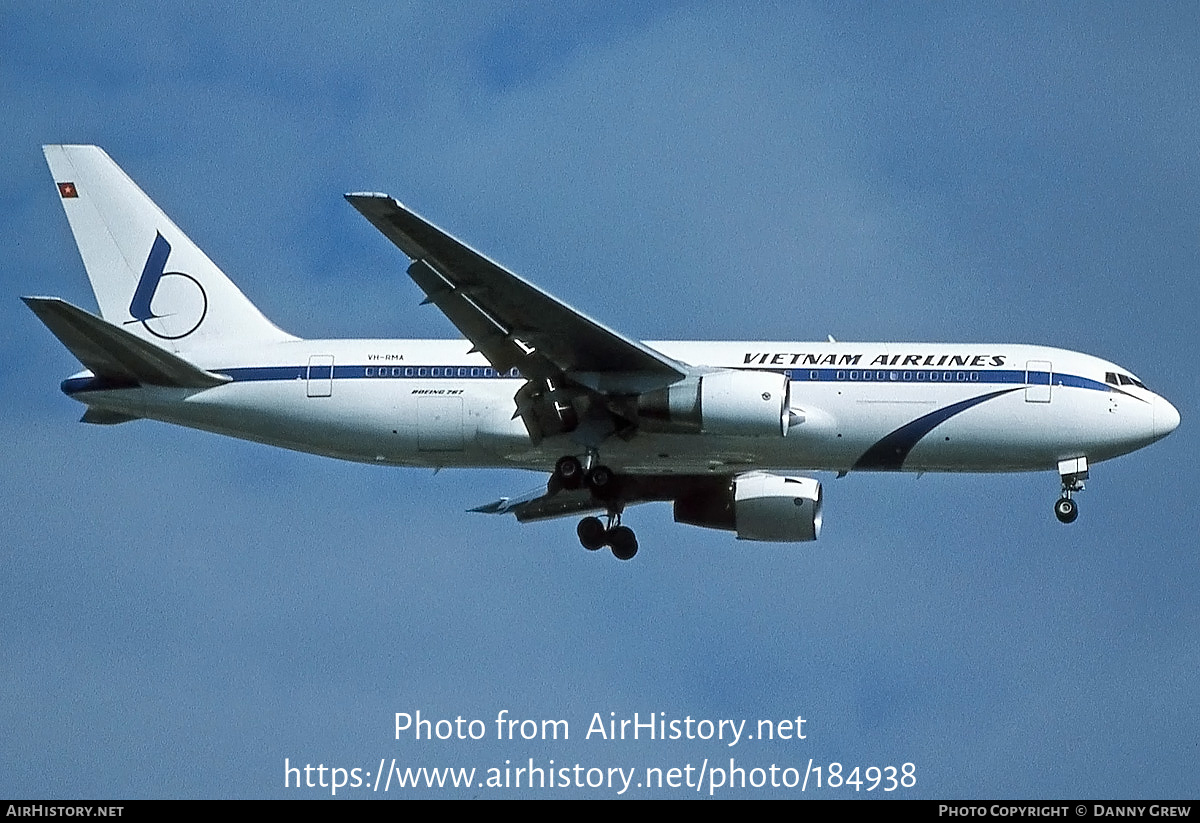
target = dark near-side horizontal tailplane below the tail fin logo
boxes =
[22,298,230,391]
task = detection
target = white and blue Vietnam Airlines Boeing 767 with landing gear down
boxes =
[23,145,1180,560]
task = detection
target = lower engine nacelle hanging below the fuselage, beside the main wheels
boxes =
[674,471,821,543]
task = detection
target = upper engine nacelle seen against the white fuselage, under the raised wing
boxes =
[637,370,791,437]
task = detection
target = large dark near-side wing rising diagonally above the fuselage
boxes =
[346,193,691,395]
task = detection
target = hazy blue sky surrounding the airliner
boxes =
[0,2,1200,798]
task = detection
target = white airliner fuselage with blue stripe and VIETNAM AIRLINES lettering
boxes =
[64,340,1178,474]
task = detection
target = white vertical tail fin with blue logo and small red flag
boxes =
[42,145,293,352]
